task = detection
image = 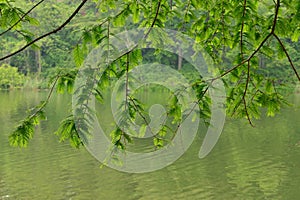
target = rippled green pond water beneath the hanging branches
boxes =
[0,91,300,200]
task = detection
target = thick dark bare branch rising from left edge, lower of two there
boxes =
[0,0,87,61]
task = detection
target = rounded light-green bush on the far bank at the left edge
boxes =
[0,64,25,89]
